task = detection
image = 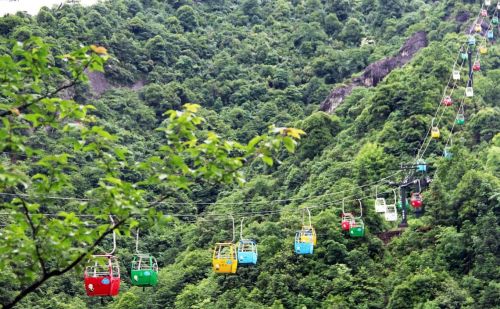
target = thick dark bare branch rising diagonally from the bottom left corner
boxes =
[3,215,131,309]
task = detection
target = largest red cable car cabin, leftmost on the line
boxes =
[84,255,120,297]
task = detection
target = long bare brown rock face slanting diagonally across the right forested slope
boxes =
[320,31,428,113]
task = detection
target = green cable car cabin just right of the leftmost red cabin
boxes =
[130,254,158,287]
